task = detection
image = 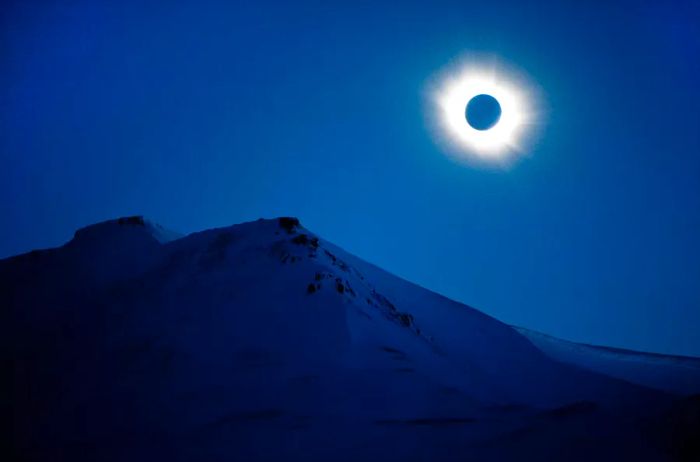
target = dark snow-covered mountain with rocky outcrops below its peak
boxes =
[0,217,700,461]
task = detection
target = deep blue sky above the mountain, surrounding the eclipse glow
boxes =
[0,0,700,355]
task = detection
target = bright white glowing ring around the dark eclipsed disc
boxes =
[430,59,539,164]
